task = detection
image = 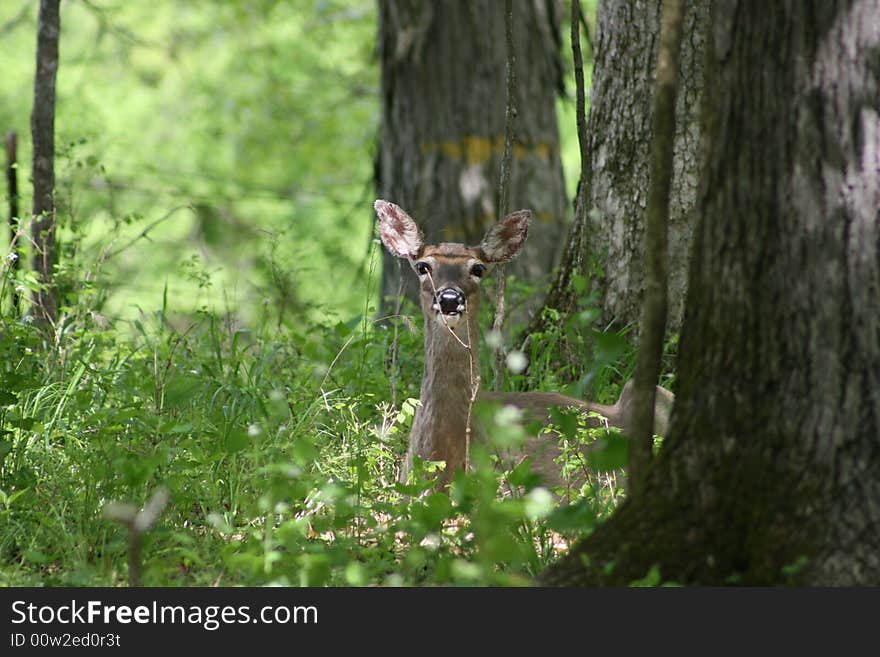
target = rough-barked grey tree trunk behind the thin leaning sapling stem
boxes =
[531,0,708,331]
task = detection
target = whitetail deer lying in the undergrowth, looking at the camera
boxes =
[375,200,674,486]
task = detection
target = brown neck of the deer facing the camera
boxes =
[408,308,480,480]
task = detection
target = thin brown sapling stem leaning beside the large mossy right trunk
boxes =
[628,0,683,497]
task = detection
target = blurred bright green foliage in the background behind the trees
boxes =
[0,0,589,322]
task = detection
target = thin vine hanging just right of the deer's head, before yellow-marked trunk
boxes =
[492,0,516,390]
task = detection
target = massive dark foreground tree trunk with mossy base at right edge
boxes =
[544,0,880,585]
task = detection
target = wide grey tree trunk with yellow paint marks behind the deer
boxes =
[376,0,567,312]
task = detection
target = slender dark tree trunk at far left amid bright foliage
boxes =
[31,0,60,324]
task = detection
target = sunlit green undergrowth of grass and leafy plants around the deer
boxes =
[0,247,672,586]
